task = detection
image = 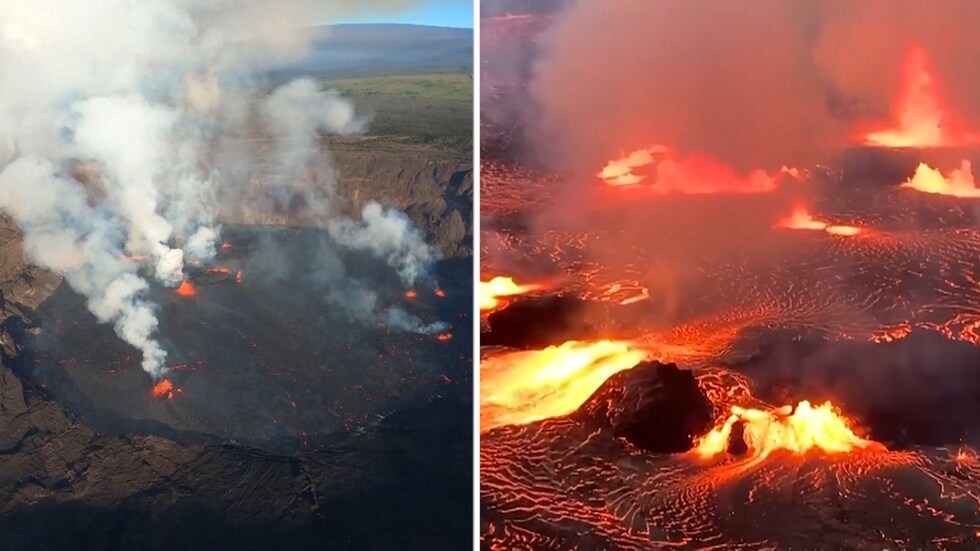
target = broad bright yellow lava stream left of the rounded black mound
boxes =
[480,341,647,431]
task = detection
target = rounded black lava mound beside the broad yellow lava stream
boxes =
[571,361,714,453]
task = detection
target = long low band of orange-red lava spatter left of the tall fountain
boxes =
[597,145,784,194]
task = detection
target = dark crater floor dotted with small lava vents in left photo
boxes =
[14,226,469,453]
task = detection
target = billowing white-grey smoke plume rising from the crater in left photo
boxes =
[0,0,456,377]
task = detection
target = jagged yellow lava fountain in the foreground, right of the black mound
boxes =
[693,400,884,459]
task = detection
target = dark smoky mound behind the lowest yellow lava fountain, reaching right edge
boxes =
[738,332,980,448]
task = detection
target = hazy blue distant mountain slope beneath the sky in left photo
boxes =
[270,24,473,78]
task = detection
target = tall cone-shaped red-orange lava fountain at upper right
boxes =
[862,45,980,148]
